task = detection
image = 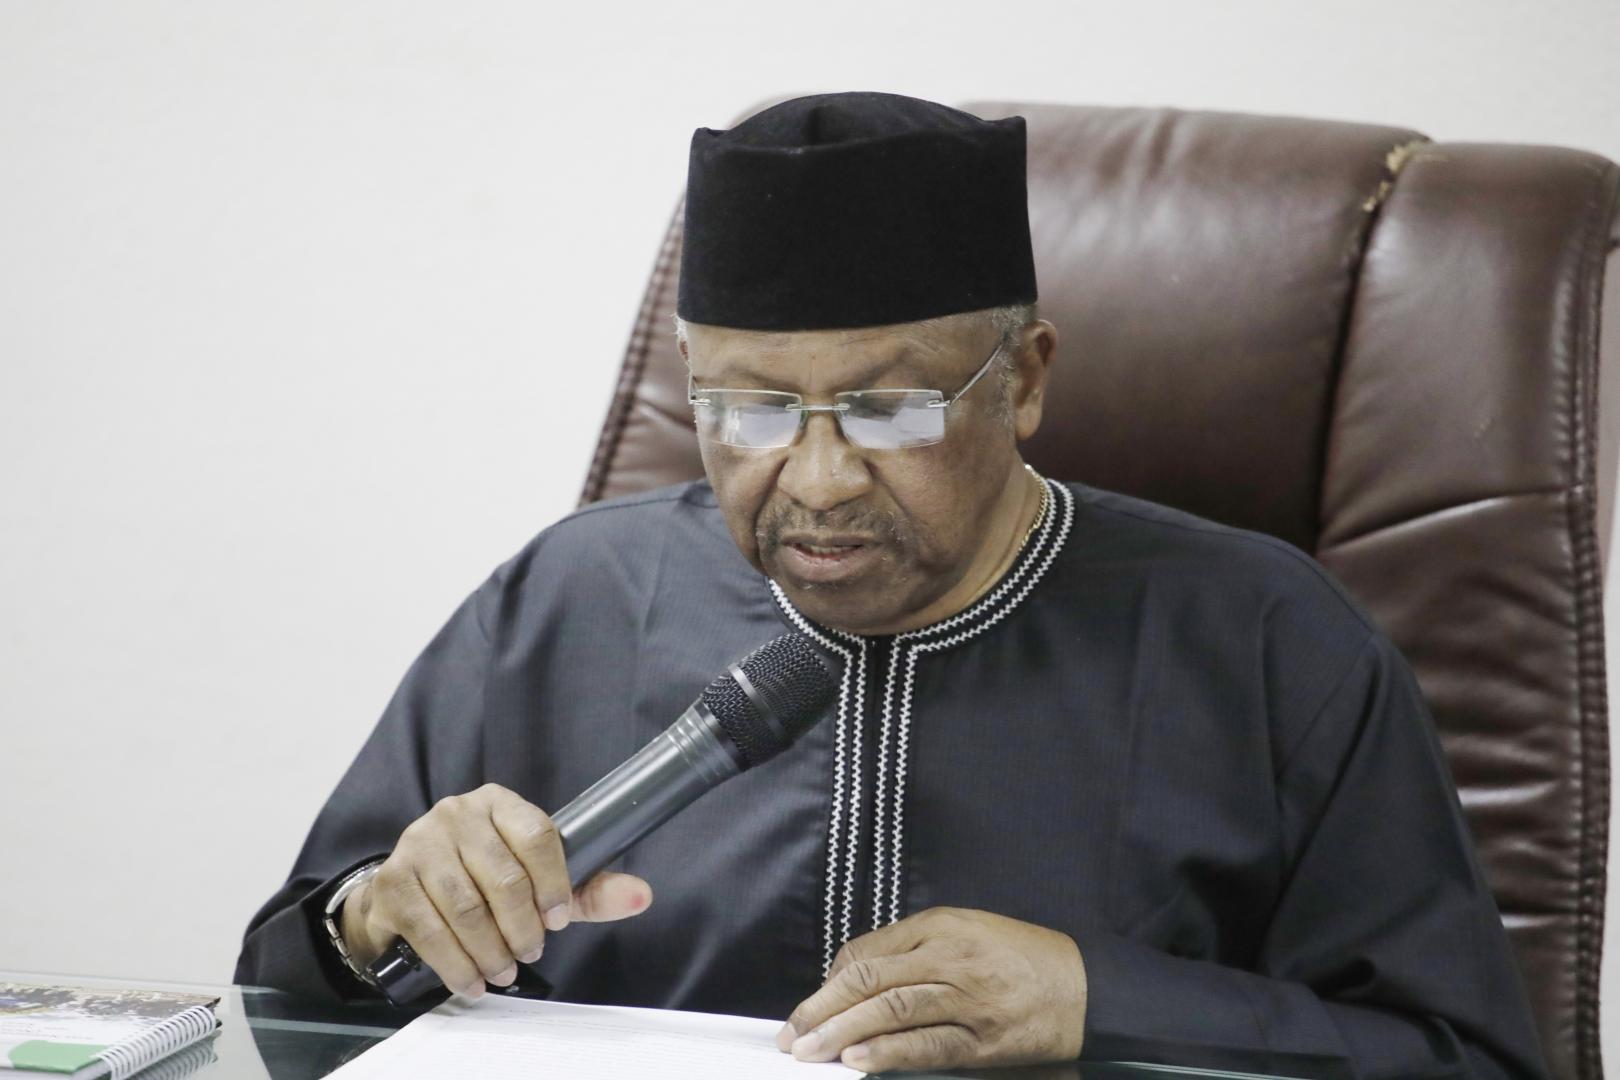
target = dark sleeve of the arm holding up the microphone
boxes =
[233,578,497,1001]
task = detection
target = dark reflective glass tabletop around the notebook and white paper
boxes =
[0,972,1275,1080]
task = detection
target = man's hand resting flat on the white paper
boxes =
[776,907,1085,1072]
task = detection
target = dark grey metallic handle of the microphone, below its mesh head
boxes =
[368,698,744,1006]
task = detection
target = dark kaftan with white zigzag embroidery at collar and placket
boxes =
[237,481,1545,1077]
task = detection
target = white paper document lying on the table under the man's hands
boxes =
[319,994,860,1080]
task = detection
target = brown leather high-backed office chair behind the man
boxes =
[583,104,1620,1080]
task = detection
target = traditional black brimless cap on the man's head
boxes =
[676,94,1035,330]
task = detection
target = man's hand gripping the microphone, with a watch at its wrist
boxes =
[342,784,653,997]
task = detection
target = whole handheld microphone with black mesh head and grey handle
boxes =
[368,633,838,1006]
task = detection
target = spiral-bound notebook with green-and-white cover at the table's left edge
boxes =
[0,983,219,1080]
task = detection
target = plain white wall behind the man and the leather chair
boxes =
[0,0,1620,1062]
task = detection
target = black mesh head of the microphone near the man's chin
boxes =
[703,633,838,769]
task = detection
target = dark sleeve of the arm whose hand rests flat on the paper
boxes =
[1077,633,1549,1080]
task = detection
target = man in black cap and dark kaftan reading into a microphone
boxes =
[237,94,1545,1077]
